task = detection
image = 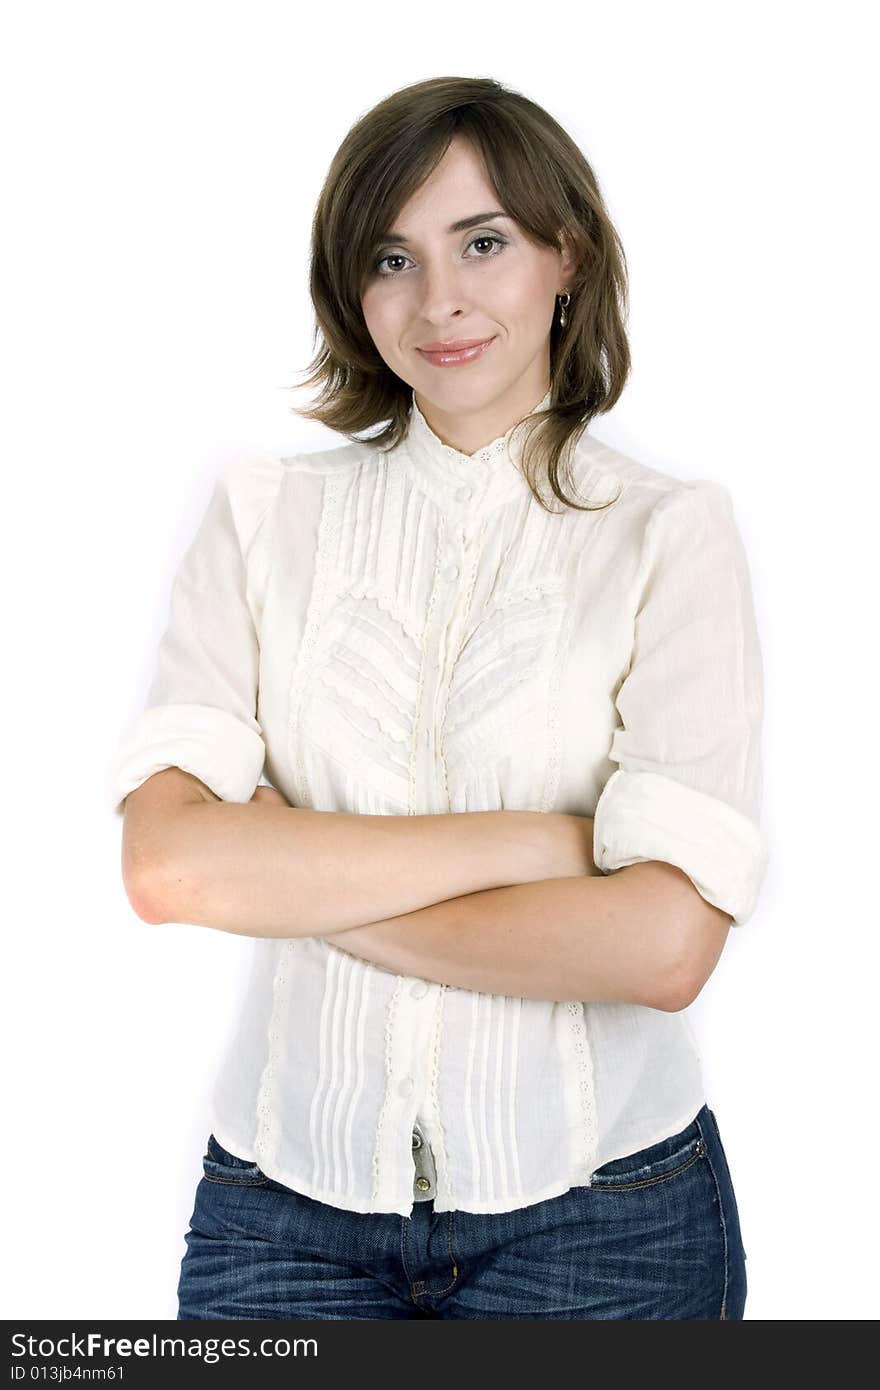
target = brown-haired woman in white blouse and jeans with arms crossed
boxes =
[114,78,766,1319]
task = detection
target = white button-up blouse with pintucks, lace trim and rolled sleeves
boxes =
[108,393,767,1216]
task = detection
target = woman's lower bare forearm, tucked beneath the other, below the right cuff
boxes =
[332,863,692,1008]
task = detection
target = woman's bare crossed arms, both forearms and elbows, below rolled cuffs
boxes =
[122,767,731,1012]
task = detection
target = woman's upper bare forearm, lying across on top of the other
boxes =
[153,801,592,937]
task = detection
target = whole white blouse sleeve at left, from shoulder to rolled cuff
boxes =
[108,456,281,815]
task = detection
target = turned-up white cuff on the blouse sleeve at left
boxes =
[108,705,266,816]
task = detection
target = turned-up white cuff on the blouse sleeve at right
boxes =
[594,767,767,927]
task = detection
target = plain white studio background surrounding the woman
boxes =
[0,0,880,1319]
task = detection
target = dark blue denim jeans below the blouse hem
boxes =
[178,1105,747,1321]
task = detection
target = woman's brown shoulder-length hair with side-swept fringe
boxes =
[292,76,630,512]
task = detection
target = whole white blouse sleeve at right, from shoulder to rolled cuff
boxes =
[594,480,767,926]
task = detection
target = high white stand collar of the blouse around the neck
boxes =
[403,391,551,513]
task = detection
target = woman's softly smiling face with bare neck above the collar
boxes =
[361,138,574,432]
